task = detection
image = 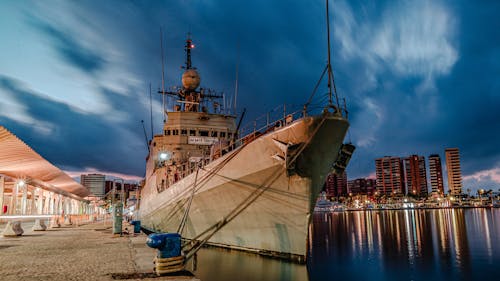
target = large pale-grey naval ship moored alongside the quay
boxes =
[138,29,354,262]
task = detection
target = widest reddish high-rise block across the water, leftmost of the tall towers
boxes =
[375,156,405,196]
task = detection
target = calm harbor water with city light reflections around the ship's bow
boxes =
[195,208,500,281]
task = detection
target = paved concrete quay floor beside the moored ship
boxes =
[0,221,200,281]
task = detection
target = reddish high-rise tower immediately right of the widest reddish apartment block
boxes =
[404,155,428,197]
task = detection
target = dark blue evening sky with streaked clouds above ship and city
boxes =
[0,0,500,191]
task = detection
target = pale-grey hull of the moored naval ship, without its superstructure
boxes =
[139,111,348,261]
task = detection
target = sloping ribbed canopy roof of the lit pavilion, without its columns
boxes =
[0,126,90,198]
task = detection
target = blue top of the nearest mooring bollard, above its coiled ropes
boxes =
[146,233,181,259]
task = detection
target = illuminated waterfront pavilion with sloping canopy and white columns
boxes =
[0,126,98,233]
